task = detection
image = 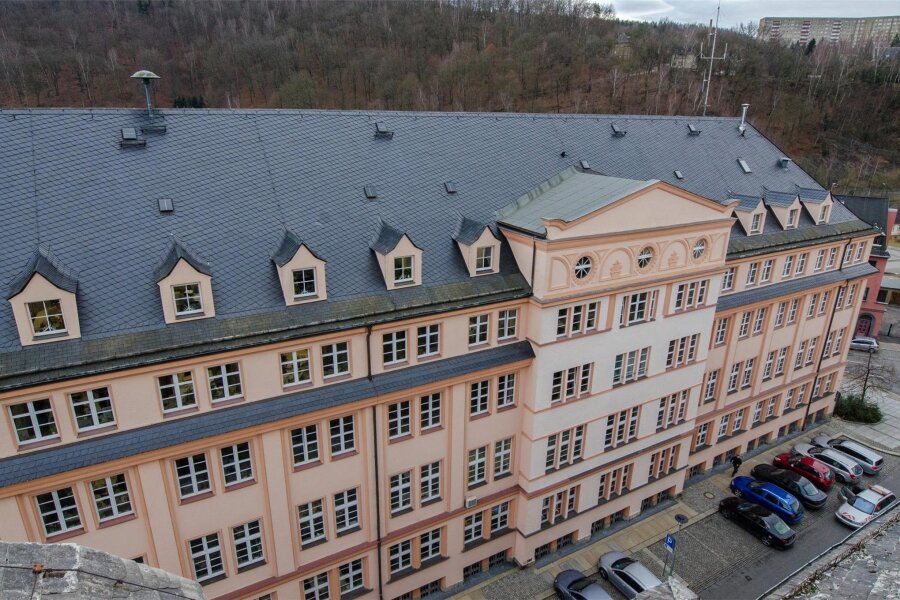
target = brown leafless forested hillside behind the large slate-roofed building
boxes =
[0,0,900,199]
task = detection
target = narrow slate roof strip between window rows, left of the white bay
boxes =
[0,342,534,488]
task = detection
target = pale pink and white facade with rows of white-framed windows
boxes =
[0,176,874,600]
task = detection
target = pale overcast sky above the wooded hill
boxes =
[608,0,900,27]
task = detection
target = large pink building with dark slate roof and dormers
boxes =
[0,110,877,600]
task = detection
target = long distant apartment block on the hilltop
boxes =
[757,16,900,48]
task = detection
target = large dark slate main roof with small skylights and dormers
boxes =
[0,109,862,368]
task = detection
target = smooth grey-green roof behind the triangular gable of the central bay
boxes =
[497,167,657,235]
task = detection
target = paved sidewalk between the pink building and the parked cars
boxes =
[453,422,832,600]
